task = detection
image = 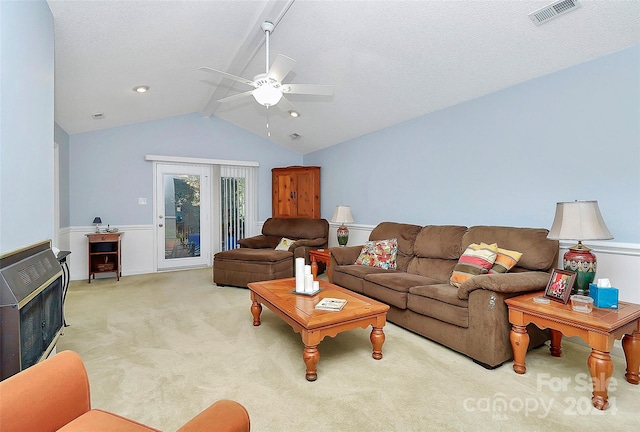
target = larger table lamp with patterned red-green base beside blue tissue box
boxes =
[547,201,613,295]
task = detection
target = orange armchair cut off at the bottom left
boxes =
[0,351,250,432]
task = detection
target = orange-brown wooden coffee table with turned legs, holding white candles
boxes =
[249,278,389,381]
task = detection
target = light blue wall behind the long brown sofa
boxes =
[304,46,640,243]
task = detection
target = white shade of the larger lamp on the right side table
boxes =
[547,201,613,241]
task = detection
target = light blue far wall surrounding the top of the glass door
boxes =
[69,113,302,226]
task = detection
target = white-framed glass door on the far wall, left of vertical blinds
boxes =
[154,164,211,270]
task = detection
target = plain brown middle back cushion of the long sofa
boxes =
[413,225,467,260]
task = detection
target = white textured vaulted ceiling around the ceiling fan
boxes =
[48,0,640,154]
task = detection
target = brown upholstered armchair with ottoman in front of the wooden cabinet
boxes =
[213,218,329,287]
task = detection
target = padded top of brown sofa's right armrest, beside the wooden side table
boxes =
[458,271,549,300]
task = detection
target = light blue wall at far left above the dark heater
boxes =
[0,0,54,253]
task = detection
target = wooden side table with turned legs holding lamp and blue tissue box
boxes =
[505,292,640,410]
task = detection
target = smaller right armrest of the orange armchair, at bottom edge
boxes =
[178,399,250,432]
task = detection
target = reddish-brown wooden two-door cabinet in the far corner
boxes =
[271,166,320,219]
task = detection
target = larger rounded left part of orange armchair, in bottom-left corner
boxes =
[0,351,91,431]
